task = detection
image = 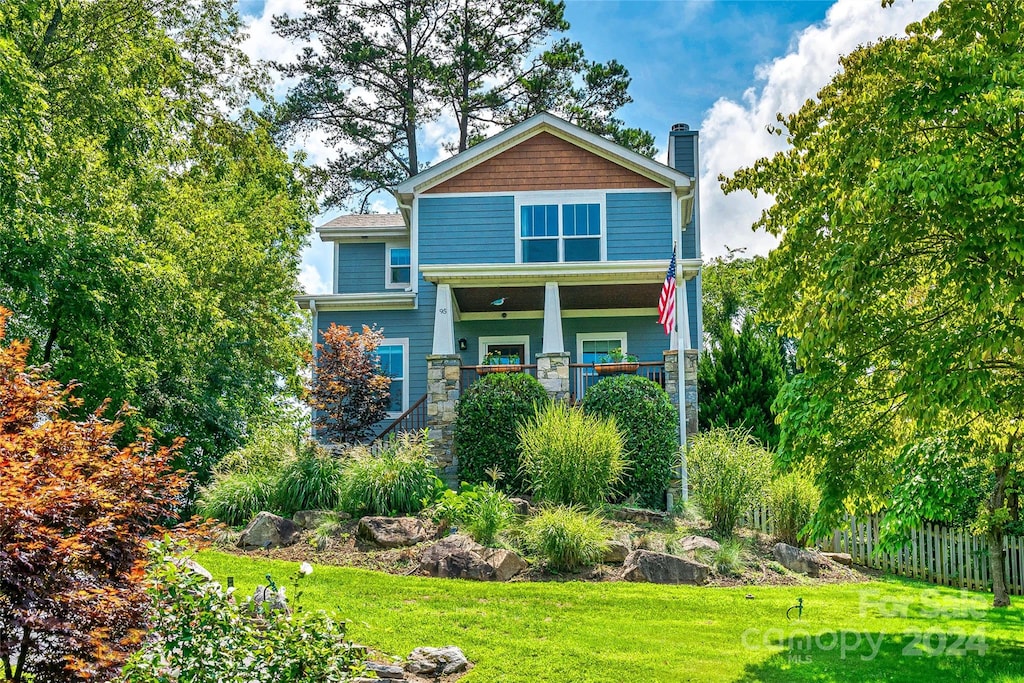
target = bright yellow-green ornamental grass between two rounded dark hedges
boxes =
[519,401,626,507]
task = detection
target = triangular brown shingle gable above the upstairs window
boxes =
[425,132,666,194]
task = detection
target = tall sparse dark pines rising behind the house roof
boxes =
[274,0,655,207]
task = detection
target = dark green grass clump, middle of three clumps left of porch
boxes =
[273,443,343,517]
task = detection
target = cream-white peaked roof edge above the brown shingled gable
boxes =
[394,112,693,201]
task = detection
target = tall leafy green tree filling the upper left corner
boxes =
[0,0,315,489]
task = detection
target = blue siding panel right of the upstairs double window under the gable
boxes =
[605,193,672,261]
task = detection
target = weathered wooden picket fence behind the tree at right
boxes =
[744,507,1024,595]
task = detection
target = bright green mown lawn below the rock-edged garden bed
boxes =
[198,551,1024,683]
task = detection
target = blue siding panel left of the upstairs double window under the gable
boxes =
[419,195,515,264]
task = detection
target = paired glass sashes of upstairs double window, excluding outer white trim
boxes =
[518,196,604,263]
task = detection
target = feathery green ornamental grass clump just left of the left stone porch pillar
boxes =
[339,432,444,515]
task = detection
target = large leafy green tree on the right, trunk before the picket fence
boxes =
[725,0,1024,606]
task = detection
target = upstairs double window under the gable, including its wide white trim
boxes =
[515,193,607,263]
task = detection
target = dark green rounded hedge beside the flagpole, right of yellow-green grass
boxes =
[583,375,679,510]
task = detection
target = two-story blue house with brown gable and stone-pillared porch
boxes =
[299,114,702,481]
